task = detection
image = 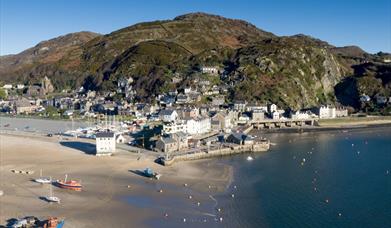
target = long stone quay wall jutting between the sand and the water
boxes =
[160,140,270,166]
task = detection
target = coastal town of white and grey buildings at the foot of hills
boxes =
[0,66,391,164]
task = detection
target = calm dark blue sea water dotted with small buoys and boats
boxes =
[216,128,391,227]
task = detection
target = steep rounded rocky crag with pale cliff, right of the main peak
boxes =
[228,37,344,108]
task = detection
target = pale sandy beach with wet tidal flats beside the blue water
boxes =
[0,134,232,227]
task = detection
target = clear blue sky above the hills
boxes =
[0,0,391,55]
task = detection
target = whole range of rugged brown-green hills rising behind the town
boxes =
[0,13,391,109]
